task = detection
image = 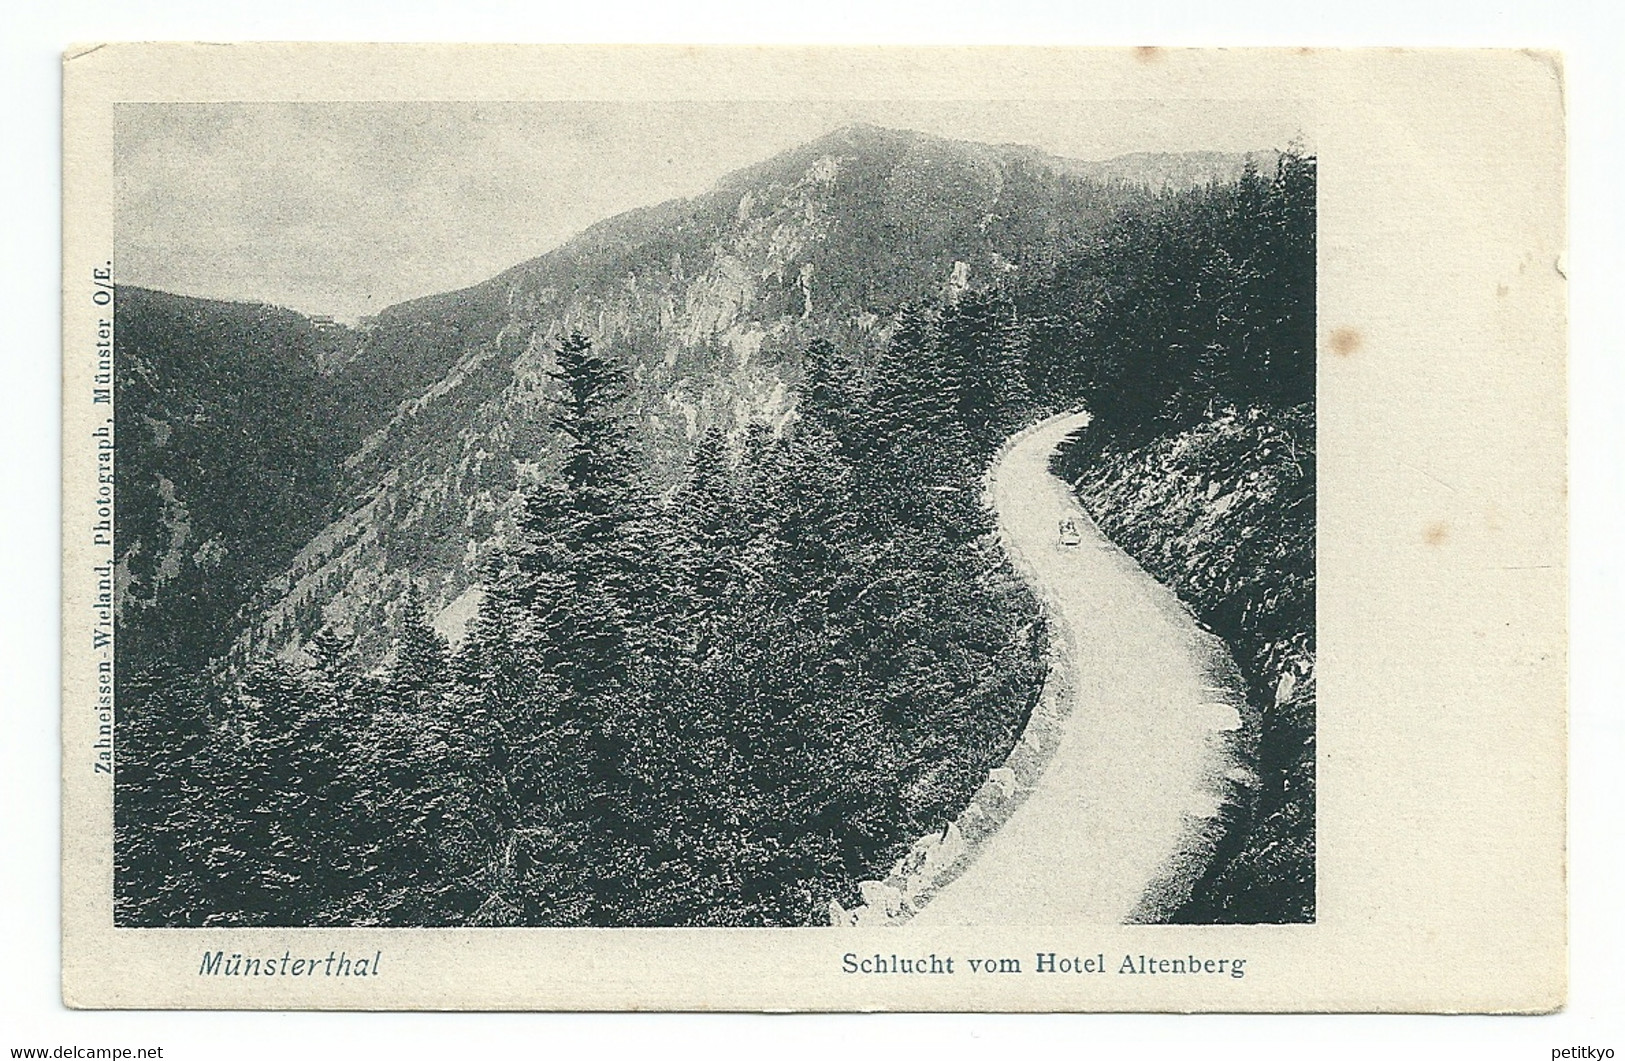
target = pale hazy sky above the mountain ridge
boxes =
[115,101,1307,318]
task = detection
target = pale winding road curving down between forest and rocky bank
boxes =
[903,413,1258,925]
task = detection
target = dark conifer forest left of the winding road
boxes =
[119,316,1043,925]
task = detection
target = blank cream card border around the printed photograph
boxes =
[62,44,1567,1012]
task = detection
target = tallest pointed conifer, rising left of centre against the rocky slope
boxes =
[470,335,653,923]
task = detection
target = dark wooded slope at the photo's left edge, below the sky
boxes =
[114,286,366,673]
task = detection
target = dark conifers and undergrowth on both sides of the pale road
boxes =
[115,144,1315,925]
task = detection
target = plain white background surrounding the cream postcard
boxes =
[0,0,1625,1061]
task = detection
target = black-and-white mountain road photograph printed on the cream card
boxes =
[111,101,1316,928]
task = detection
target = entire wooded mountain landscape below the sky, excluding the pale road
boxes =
[115,128,1313,926]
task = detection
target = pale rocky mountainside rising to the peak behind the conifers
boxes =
[120,127,1267,660]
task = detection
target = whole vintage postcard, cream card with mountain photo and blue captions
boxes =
[62,44,1567,1012]
